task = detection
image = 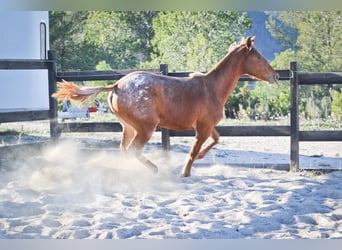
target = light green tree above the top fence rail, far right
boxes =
[268,11,342,72]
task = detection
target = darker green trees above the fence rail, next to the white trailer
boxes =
[50,11,156,71]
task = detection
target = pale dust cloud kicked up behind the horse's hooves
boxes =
[6,141,184,200]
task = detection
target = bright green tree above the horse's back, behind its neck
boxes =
[141,11,251,71]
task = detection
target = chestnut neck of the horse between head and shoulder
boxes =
[207,51,243,105]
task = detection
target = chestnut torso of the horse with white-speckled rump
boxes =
[113,71,208,129]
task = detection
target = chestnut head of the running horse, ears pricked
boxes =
[241,36,279,83]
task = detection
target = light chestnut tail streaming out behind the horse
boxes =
[52,81,116,102]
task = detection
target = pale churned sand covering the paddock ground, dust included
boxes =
[0,135,342,239]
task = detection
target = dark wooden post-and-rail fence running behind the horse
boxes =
[0,51,342,171]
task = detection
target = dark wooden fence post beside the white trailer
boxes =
[48,50,61,140]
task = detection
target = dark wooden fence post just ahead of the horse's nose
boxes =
[290,62,299,171]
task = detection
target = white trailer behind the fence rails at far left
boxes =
[0,11,49,123]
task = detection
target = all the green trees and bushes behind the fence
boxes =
[50,11,342,123]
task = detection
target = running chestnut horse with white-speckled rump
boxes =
[53,36,279,177]
